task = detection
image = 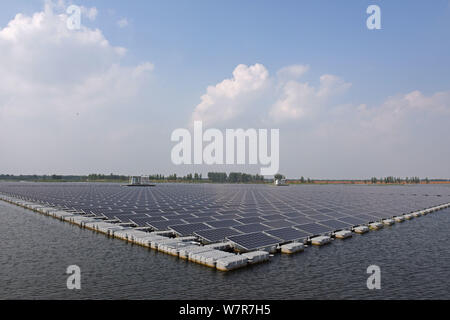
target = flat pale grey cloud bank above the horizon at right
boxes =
[292,91,450,178]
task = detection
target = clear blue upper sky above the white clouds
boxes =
[0,0,450,103]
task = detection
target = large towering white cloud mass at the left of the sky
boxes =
[0,1,154,172]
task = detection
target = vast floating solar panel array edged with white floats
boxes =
[0,183,450,271]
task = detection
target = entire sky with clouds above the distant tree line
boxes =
[0,0,450,179]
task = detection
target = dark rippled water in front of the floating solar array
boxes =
[0,201,450,299]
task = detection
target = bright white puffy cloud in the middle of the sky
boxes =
[191,64,351,125]
